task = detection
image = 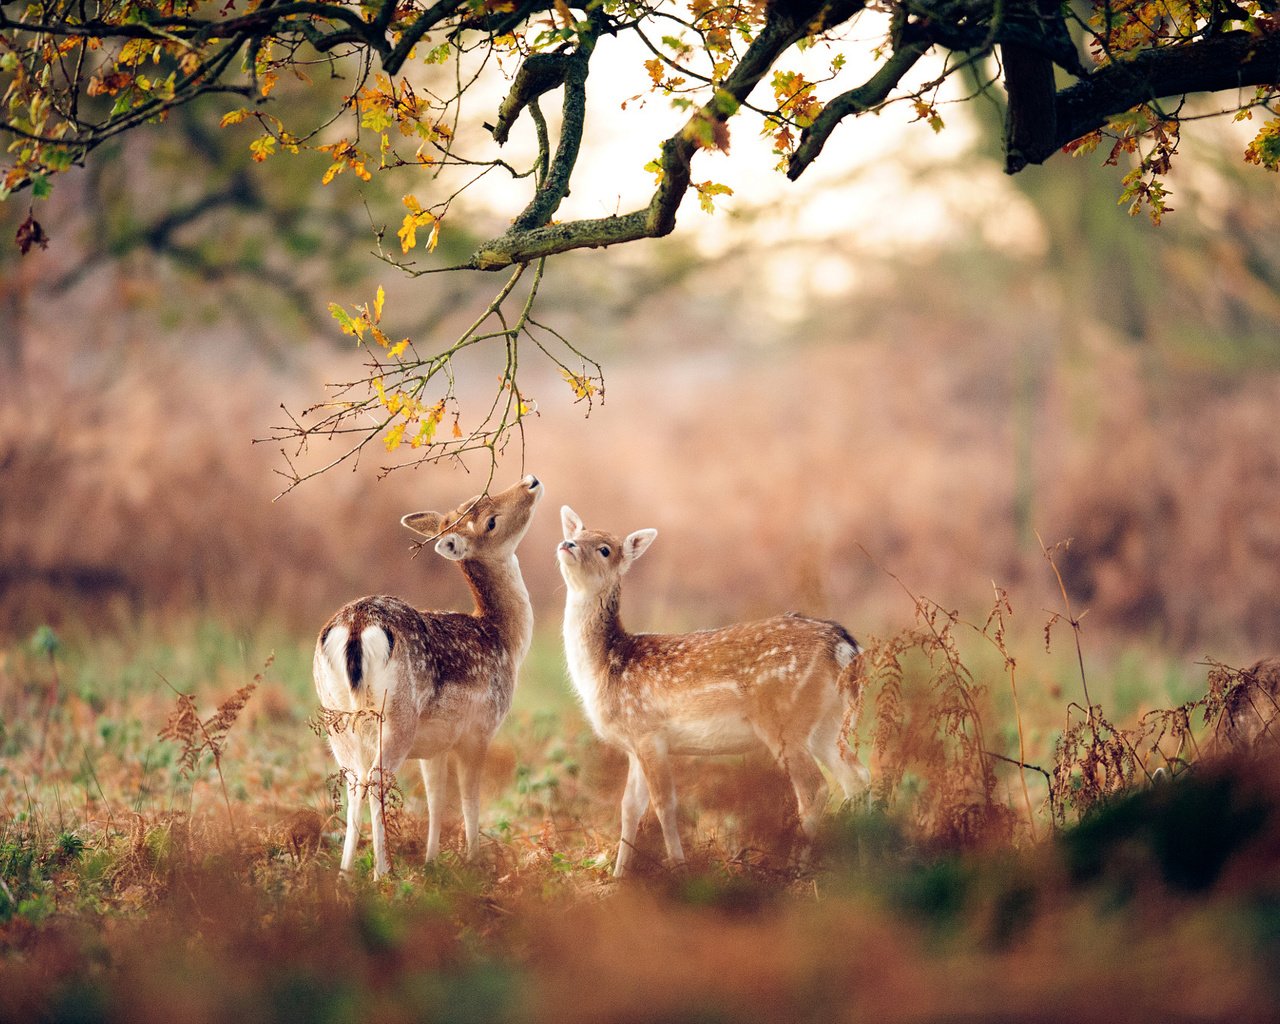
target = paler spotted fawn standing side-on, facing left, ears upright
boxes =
[557,506,870,876]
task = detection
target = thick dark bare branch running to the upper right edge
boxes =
[1024,32,1280,166]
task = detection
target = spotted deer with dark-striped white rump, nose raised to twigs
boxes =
[312,476,543,876]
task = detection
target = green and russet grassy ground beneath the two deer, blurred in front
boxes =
[0,611,1280,1021]
